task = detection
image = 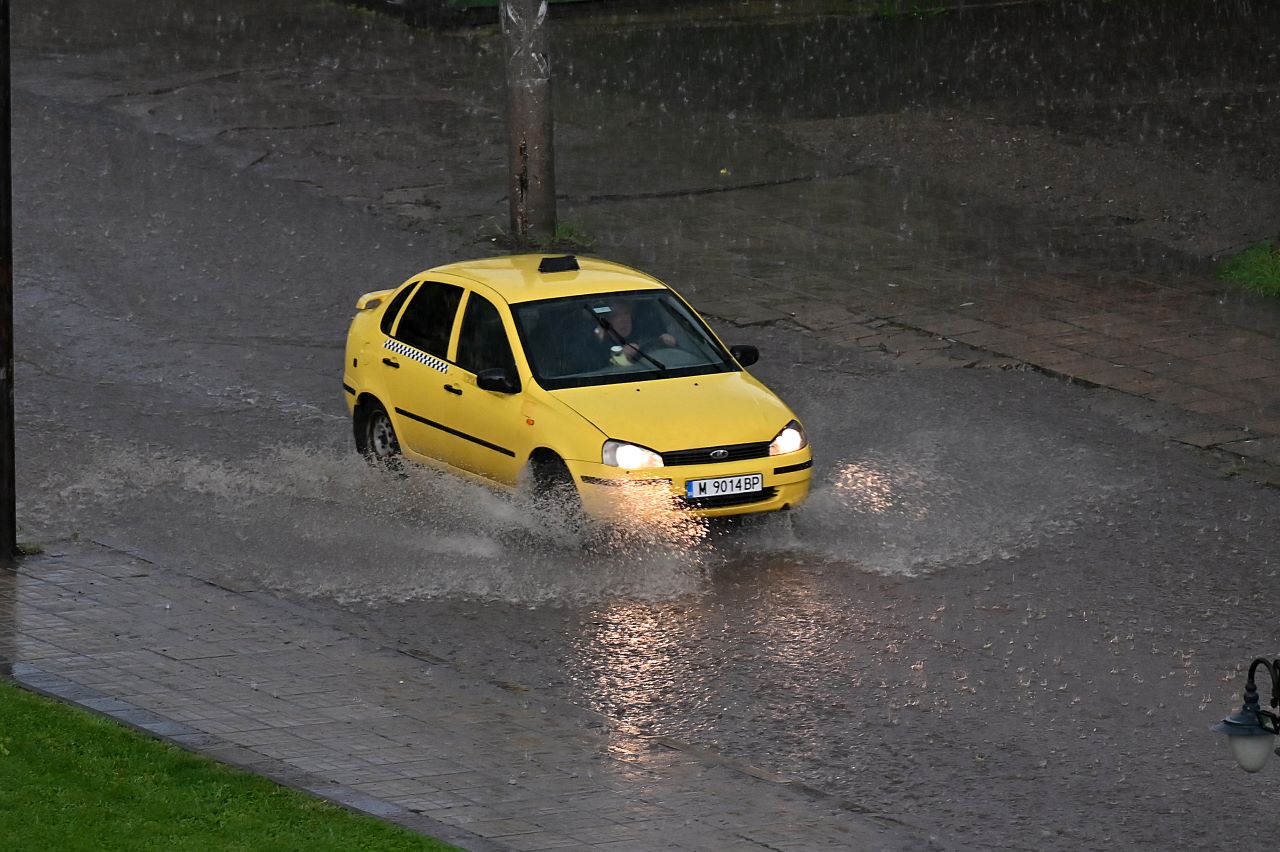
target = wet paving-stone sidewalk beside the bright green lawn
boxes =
[0,546,952,852]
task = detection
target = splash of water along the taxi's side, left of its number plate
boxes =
[23,448,713,604]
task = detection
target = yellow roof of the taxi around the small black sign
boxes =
[425,255,668,303]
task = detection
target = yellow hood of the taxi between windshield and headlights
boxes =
[553,372,794,453]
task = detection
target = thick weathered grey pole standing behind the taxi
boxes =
[499,0,556,244]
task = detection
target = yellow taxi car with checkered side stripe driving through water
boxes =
[342,255,813,518]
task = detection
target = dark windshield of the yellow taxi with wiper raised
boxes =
[512,290,739,390]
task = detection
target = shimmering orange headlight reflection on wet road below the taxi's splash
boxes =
[567,560,865,742]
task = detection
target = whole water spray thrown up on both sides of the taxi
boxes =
[22,406,1134,596]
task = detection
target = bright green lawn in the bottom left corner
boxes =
[0,681,453,852]
